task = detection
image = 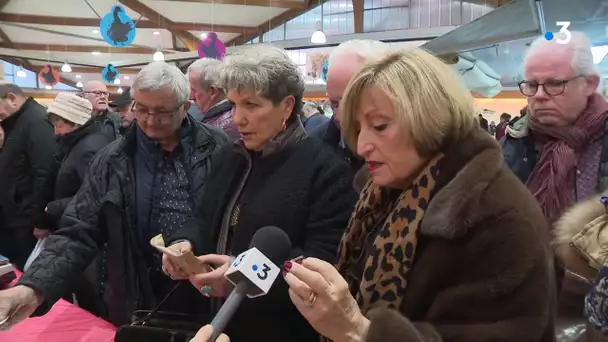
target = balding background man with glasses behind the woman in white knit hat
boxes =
[82,81,122,141]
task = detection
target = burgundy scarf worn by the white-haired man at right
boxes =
[526,93,608,223]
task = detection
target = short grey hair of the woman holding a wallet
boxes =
[219,44,304,116]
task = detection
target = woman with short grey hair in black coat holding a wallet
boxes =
[163,45,356,342]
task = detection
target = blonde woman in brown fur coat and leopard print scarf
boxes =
[284,49,554,342]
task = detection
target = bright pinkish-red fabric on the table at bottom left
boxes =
[0,274,117,342]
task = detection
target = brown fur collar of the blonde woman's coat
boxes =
[421,129,506,239]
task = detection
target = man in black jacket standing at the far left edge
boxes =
[0,83,57,268]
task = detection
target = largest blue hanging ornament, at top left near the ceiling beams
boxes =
[99,5,135,47]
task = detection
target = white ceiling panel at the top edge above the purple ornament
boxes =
[142,1,287,27]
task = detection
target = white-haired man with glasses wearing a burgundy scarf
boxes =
[503,32,608,224]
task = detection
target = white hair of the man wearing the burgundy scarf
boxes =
[524,31,598,76]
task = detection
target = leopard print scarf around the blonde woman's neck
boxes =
[336,155,443,314]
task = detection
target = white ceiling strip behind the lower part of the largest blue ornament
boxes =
[0,23,173,48]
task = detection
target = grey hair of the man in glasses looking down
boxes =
[131,61,190,105]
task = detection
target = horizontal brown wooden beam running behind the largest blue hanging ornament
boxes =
[0,13,255,33]
